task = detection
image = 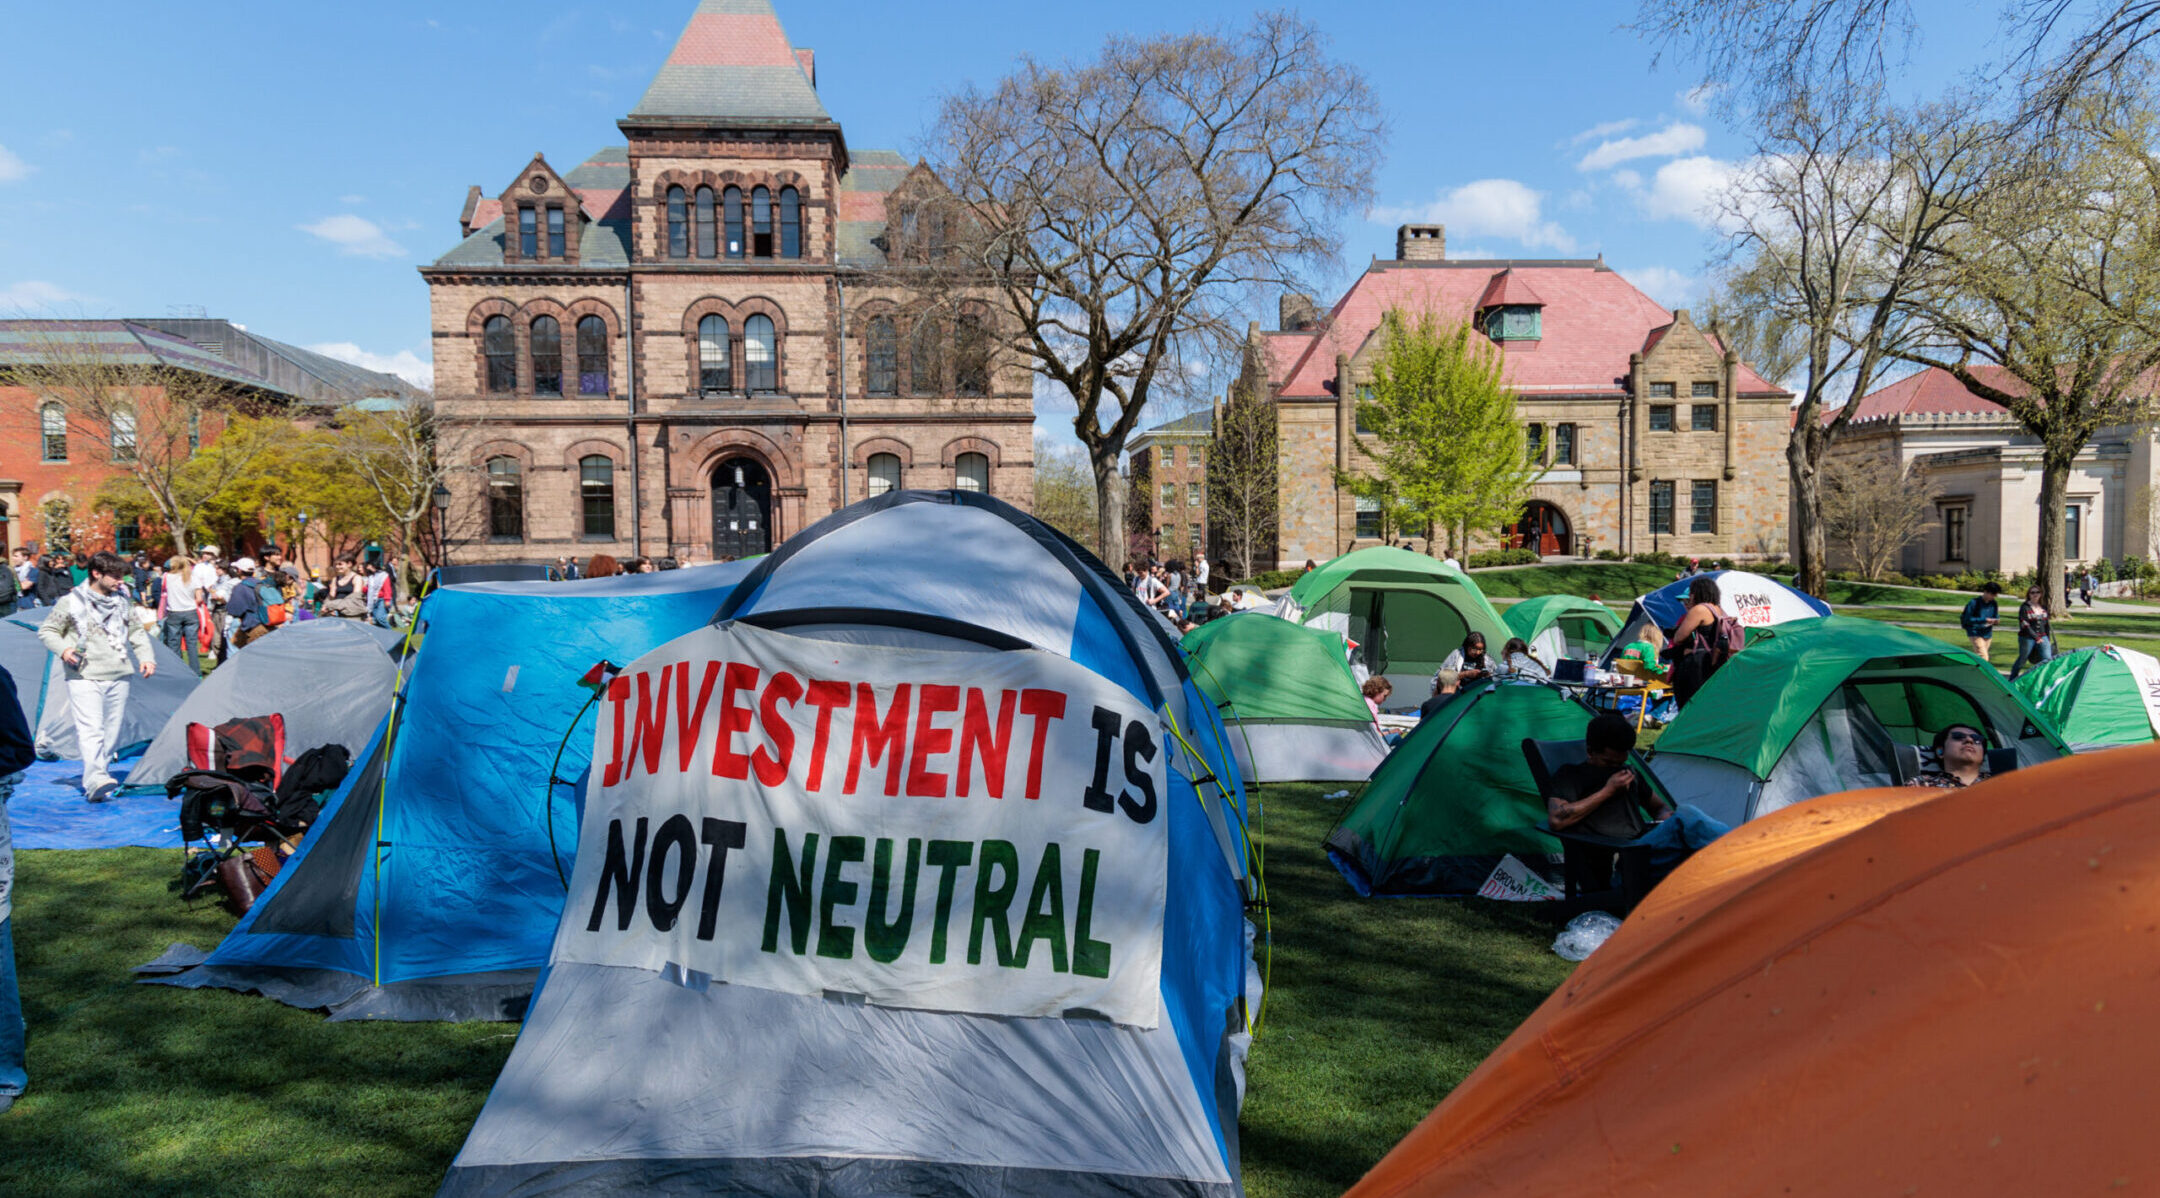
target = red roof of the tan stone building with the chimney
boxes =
[1268,261,1782,399]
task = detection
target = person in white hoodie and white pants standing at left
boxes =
[37,553,158,803]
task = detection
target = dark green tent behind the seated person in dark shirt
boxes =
[1328,682,1648,894]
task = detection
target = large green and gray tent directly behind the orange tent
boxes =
[1652,615,2069,825]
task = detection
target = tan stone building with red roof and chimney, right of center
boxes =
[1242,224,1791,568]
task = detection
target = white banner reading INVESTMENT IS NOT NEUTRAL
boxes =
[555,624,1169,1027]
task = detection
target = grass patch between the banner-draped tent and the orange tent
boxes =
[1240,786,1572,1198]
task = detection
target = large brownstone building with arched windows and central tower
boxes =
[421,0,1035,561]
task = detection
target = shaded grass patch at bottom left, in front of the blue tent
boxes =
[0,848,516,1198]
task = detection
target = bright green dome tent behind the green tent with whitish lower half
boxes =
[1277,546,1508,699]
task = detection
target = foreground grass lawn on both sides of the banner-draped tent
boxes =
[0,786,1570,1198]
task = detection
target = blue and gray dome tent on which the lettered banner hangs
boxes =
[443,490,1257,1198]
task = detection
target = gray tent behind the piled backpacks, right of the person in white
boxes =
[127,620,397,788]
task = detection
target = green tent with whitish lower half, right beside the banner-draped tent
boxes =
[1179,611,1387,781]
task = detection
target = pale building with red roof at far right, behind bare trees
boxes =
[1825,365,2160,574]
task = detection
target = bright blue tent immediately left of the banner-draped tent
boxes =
[153,563,752,1019]
